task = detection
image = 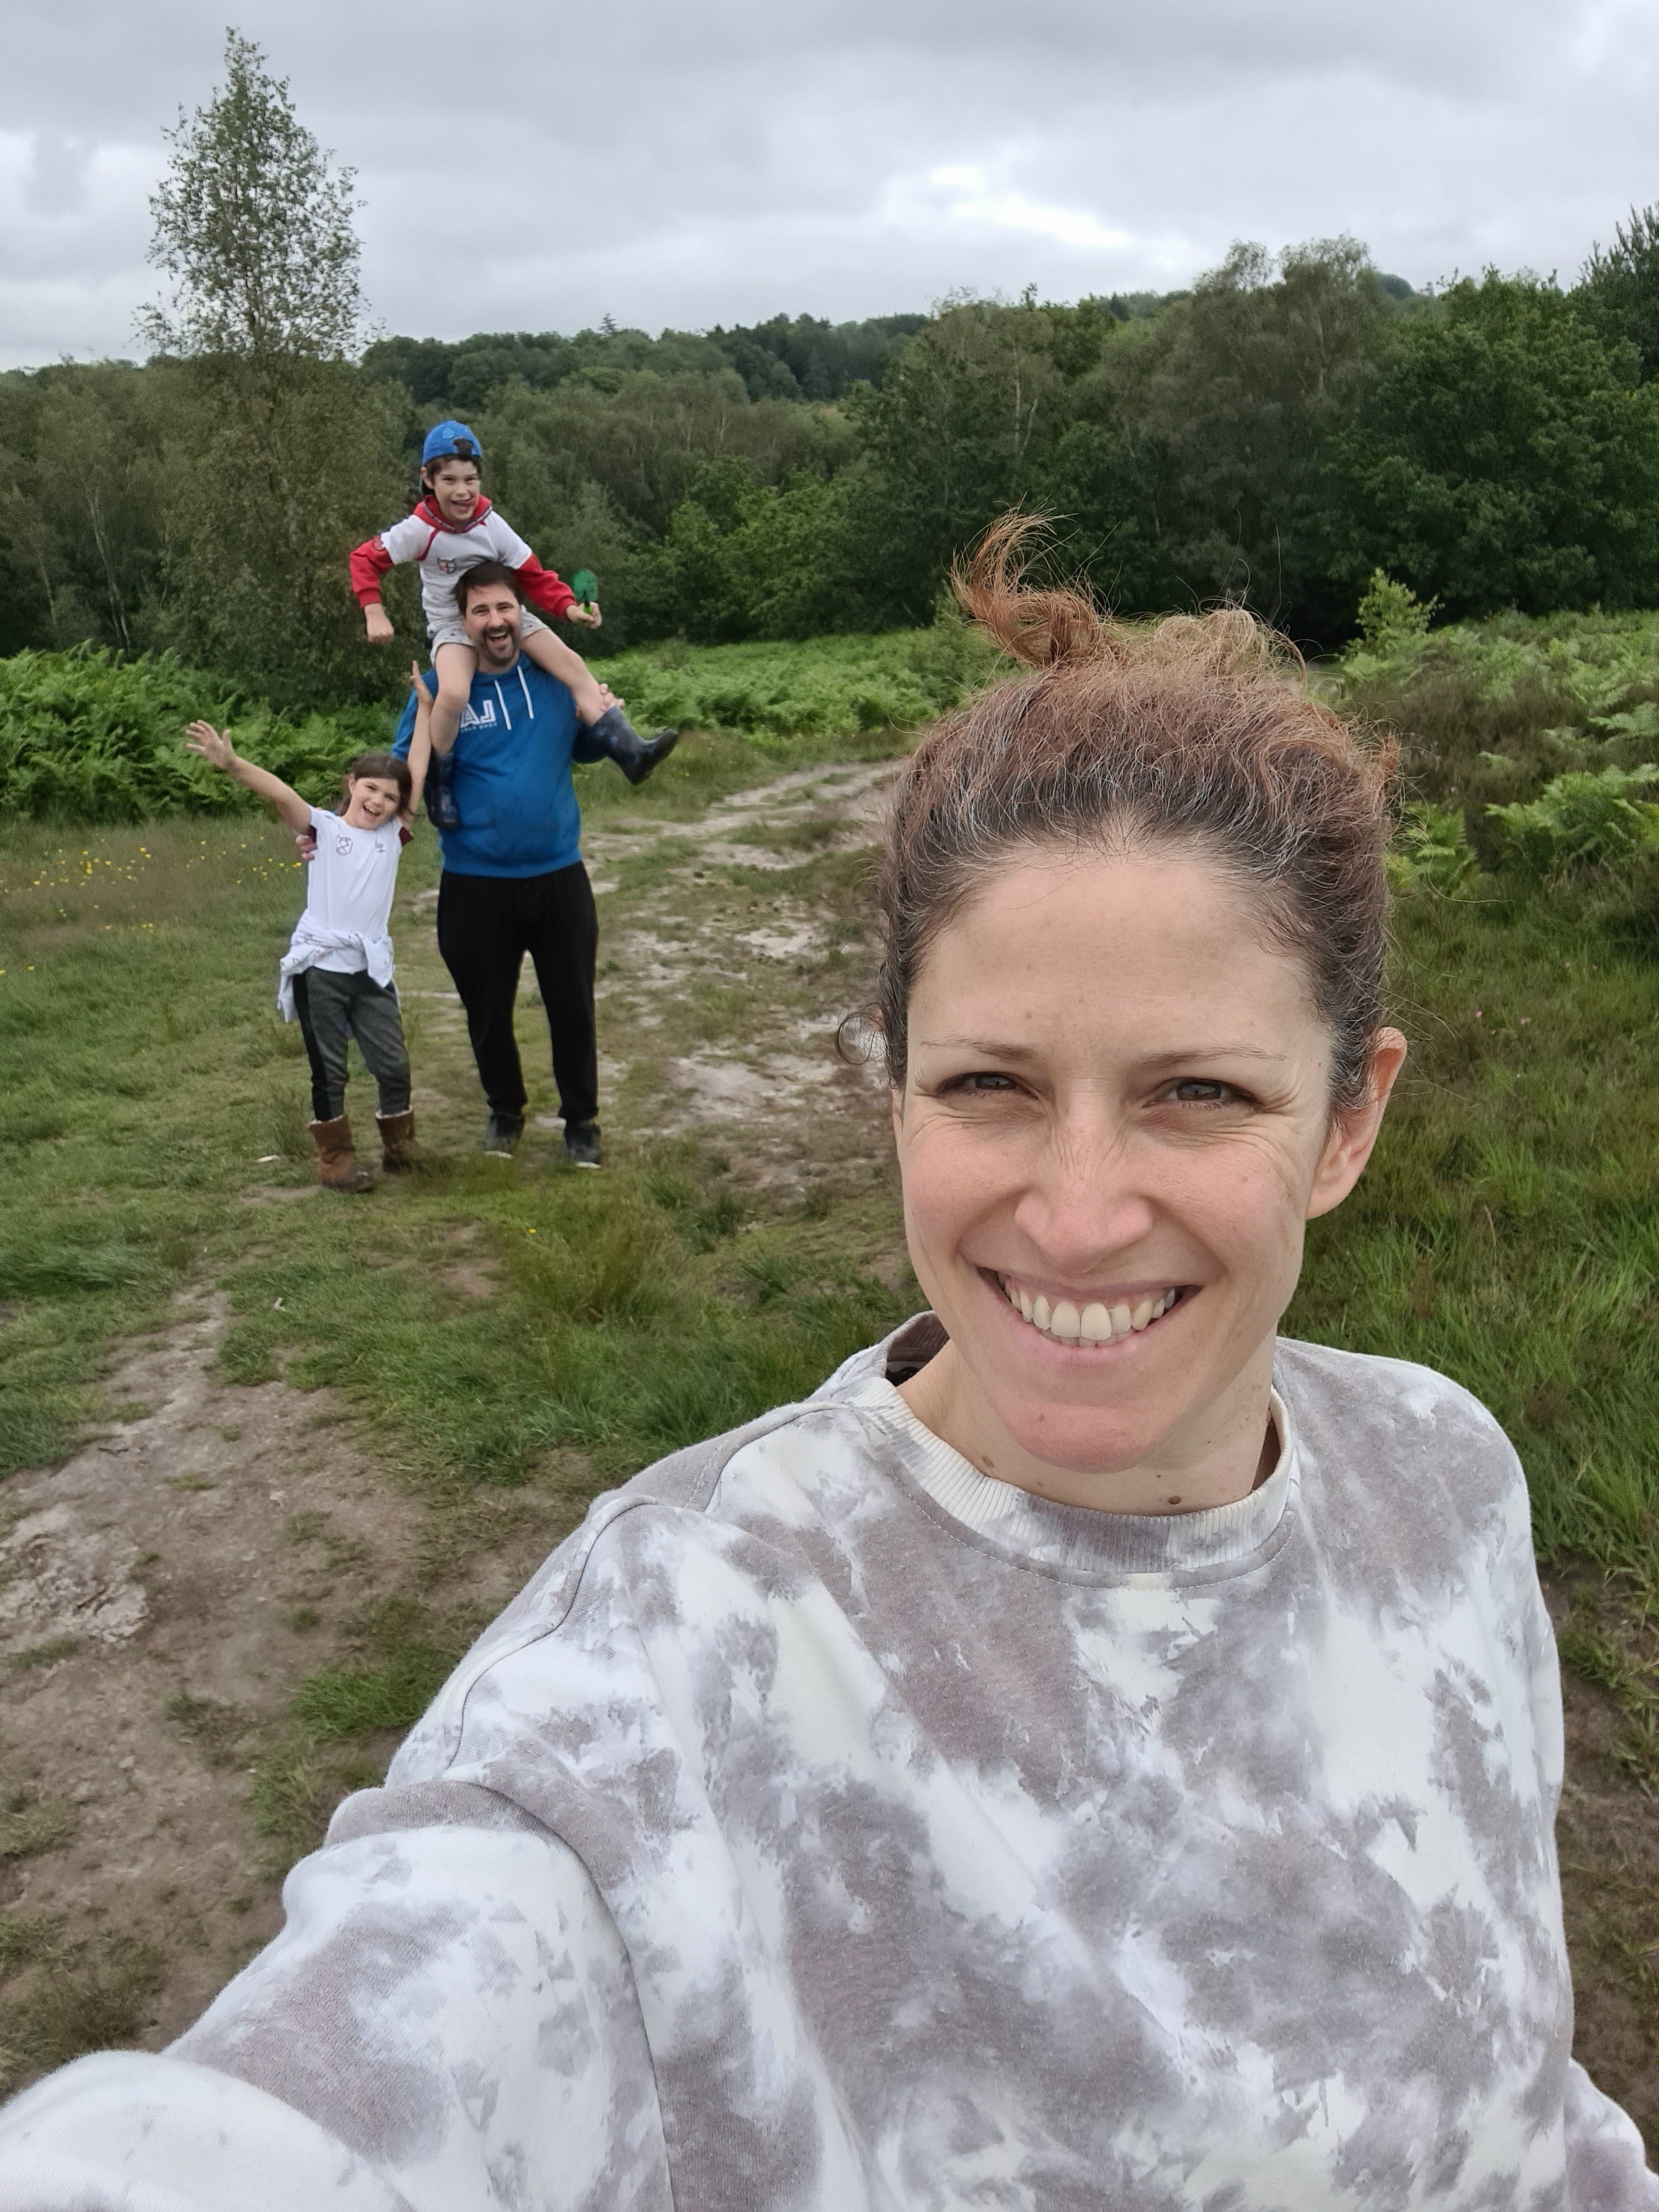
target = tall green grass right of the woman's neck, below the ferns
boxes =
[1287,894,1659,1588]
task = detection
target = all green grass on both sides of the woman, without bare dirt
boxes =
[0,663,1659,2077]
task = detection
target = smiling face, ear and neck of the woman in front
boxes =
[894,851,1404,1513]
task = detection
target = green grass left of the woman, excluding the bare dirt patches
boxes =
[0,732,909,1885]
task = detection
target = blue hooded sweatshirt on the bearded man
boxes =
[392,657,604,876]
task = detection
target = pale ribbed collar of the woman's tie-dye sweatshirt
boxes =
[832,1314,1296,1575]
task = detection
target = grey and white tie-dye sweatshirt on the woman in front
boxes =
[0,1321,1659,2212]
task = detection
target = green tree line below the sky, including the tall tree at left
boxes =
[0,33,1659,699]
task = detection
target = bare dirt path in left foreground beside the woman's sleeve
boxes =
[0,1298,414,2044]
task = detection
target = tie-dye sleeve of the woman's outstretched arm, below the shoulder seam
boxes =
[0,1781,672,2212]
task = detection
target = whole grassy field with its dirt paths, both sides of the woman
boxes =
[0,632,1659,2128]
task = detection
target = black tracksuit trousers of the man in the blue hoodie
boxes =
[438,860,600,1124]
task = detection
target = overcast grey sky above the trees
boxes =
[0,0,1659,365]
